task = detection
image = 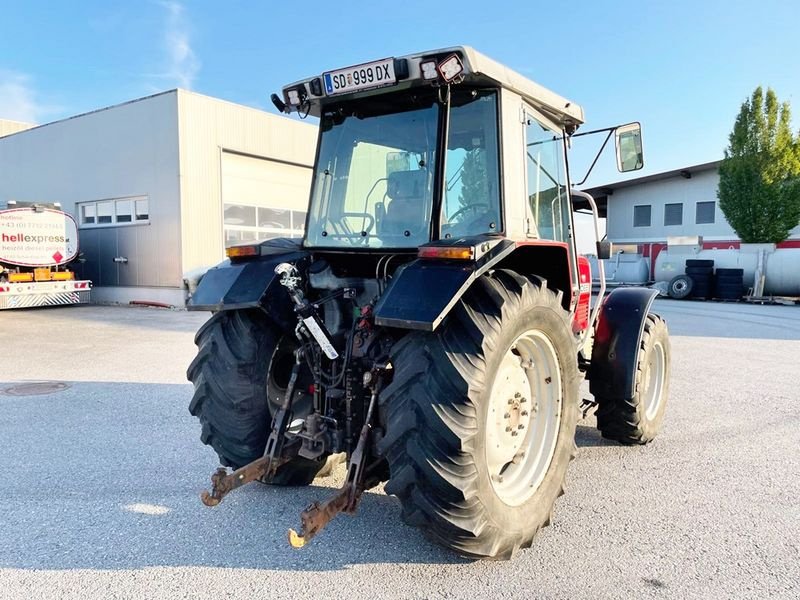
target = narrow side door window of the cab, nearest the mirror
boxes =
[525,114,569,242]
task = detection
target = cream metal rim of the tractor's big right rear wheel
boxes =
[486,330,563,506]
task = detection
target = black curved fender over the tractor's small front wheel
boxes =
[587,288,658,400]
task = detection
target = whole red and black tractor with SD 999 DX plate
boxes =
[188,47,670,559]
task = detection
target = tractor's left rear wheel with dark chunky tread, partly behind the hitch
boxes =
[186,309,325,485]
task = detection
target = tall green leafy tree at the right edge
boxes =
[717,87,800,243]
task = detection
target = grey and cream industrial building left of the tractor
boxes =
[0,89,316,306]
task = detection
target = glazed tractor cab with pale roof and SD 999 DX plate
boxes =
[273,47,583,251]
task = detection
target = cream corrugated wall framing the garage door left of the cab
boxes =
[178,90,317,271]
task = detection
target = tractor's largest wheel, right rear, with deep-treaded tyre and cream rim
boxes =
[379,271,579,559]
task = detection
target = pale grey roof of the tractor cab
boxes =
[283,46,584,130]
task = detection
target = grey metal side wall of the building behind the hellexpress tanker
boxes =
[0,90,182,297]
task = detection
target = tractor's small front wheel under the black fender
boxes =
[595,314,670,444]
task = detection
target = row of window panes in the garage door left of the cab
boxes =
[223,204,306,248]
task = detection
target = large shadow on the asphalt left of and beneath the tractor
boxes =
[0,382,469,572]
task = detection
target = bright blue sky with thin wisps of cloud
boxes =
[0,0,800,184]
